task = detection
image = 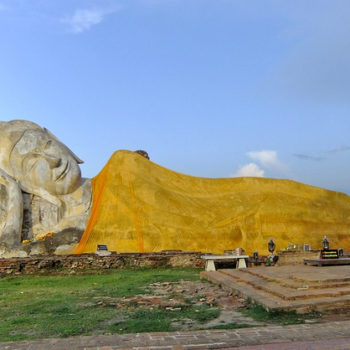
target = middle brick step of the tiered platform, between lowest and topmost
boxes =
[218,269,350,300]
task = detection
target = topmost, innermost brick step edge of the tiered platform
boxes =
[240,268,350,289]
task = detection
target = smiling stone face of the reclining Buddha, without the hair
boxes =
[10,129,82,195]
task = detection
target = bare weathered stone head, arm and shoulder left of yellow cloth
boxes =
[0,120,91,257]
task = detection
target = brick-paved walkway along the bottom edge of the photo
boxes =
[0,321,350,350]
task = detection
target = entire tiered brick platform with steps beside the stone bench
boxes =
[201,265,350,313]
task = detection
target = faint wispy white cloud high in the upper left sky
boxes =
[61,9,116,34]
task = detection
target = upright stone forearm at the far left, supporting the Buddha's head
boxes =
[0,169,23,248]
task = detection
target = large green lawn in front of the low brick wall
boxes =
[0,268,208,341]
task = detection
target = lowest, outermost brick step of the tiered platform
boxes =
[201,271,350,314]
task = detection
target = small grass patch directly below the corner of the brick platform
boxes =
[240,304,319,325]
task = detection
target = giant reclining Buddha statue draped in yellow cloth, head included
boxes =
[0,120,350,257]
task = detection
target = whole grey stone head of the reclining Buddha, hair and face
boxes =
[0,120,82,196]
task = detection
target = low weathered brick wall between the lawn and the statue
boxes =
[0,252,205,276]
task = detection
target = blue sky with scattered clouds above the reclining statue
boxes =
[0,0,350,194]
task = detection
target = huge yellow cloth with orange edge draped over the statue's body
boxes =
[75,151,350,253]
